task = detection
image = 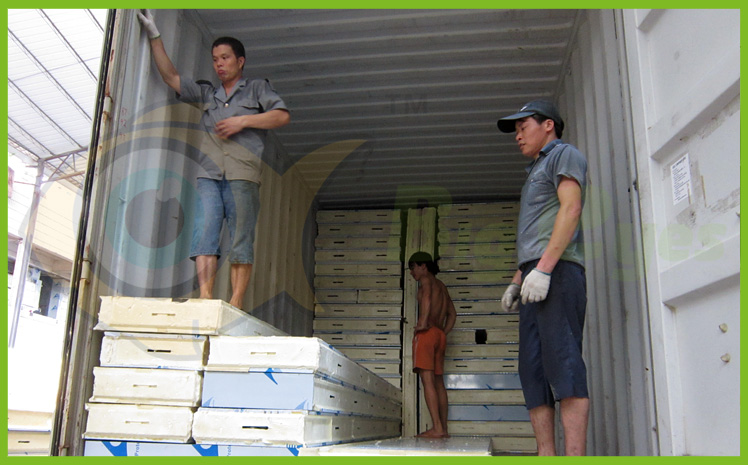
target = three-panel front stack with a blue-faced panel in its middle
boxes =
[192,336,401,447]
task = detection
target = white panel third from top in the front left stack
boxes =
[90,367,202,407]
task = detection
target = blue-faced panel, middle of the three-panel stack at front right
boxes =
[202,372,400,418]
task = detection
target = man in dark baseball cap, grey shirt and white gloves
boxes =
[497,100,589,455]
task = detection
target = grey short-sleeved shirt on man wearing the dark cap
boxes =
[517,139,587,266]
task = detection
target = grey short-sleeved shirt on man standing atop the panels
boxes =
[178,76,287,184]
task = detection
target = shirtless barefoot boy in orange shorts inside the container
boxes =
[408,252,457,438]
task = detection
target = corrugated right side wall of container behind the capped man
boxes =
[558,11,656,455]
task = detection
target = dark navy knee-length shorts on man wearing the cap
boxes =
[519,260,589,410]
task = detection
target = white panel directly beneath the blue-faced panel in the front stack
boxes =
[192,408,400,447]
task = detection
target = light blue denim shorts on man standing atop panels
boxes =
[190,178,260,264]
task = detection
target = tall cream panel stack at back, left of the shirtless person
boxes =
[314,210,403,388]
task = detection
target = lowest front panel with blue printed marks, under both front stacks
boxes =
[83,440,301,457]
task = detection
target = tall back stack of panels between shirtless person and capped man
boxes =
[437,202,536,454]
